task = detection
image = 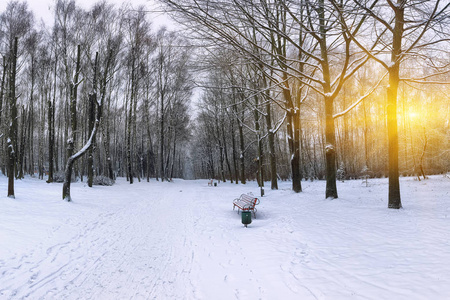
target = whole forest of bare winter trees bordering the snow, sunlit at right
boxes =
[0,0,450,208]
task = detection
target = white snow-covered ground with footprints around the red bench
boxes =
[0,175,450,300]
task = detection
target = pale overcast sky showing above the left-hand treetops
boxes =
[0,0,169,25]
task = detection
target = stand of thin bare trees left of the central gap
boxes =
[0,0,192,199]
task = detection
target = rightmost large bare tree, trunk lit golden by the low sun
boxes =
[331,0,450,209]
